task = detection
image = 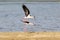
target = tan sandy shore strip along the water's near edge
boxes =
[0,32,60,40]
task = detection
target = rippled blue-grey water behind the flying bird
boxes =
[0,2,60,32]
